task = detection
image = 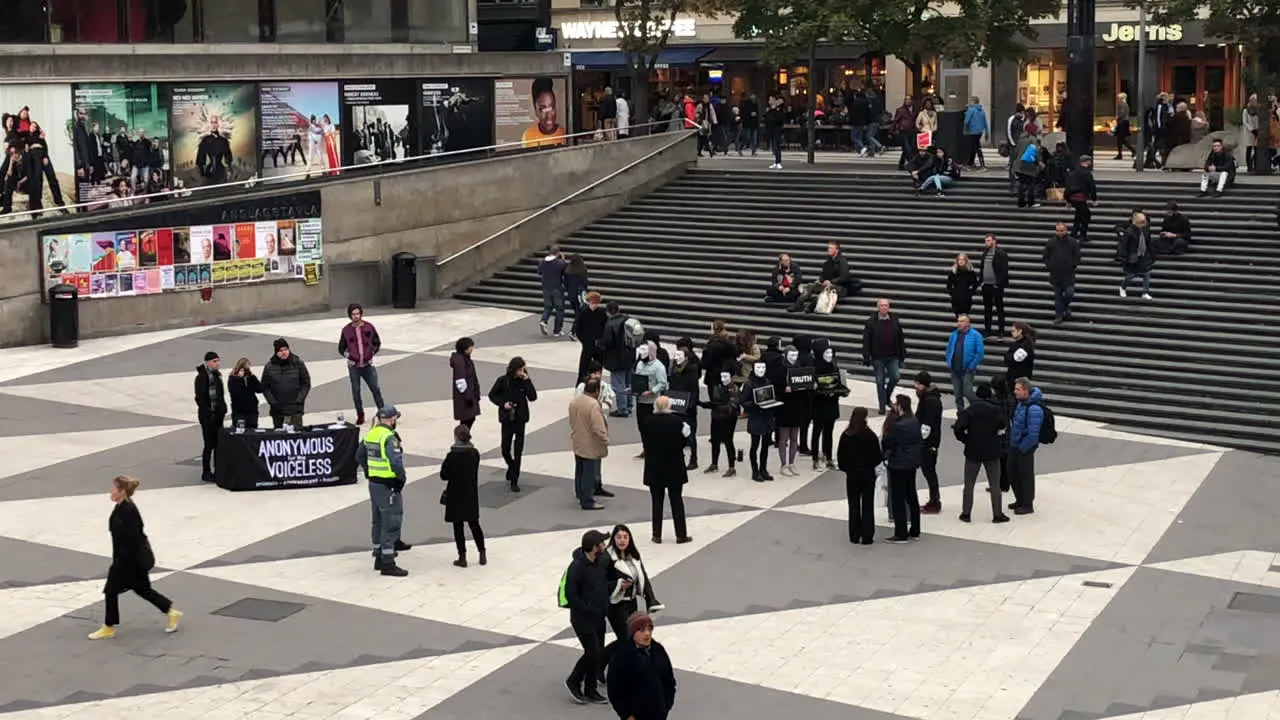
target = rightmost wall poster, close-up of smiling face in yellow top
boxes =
[493,77,568,150]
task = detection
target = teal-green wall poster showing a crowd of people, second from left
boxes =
[72,82,173,210]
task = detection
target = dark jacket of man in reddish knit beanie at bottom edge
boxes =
[608,638,676,720]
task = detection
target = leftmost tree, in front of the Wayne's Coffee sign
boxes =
[613,0,714,133]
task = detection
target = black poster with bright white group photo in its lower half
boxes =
[340,78,419,165]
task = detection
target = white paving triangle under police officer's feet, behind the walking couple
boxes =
[195,511,758,641]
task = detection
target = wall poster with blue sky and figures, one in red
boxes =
[259,82,342,179]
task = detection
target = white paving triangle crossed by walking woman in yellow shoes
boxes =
[0,466,436,570]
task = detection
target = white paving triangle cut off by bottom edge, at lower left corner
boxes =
[5,644,535,720]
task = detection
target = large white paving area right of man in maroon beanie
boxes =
[658,568,1133,720]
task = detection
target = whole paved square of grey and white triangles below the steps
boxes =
[0,299,1280,720]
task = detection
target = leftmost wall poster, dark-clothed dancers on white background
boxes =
[0,83,76,222]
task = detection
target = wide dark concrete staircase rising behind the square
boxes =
[460,168,1280,452]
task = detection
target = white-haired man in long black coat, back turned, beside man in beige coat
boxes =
[640,396,694,544]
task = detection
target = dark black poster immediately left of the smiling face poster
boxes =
[420,78,494,155]
